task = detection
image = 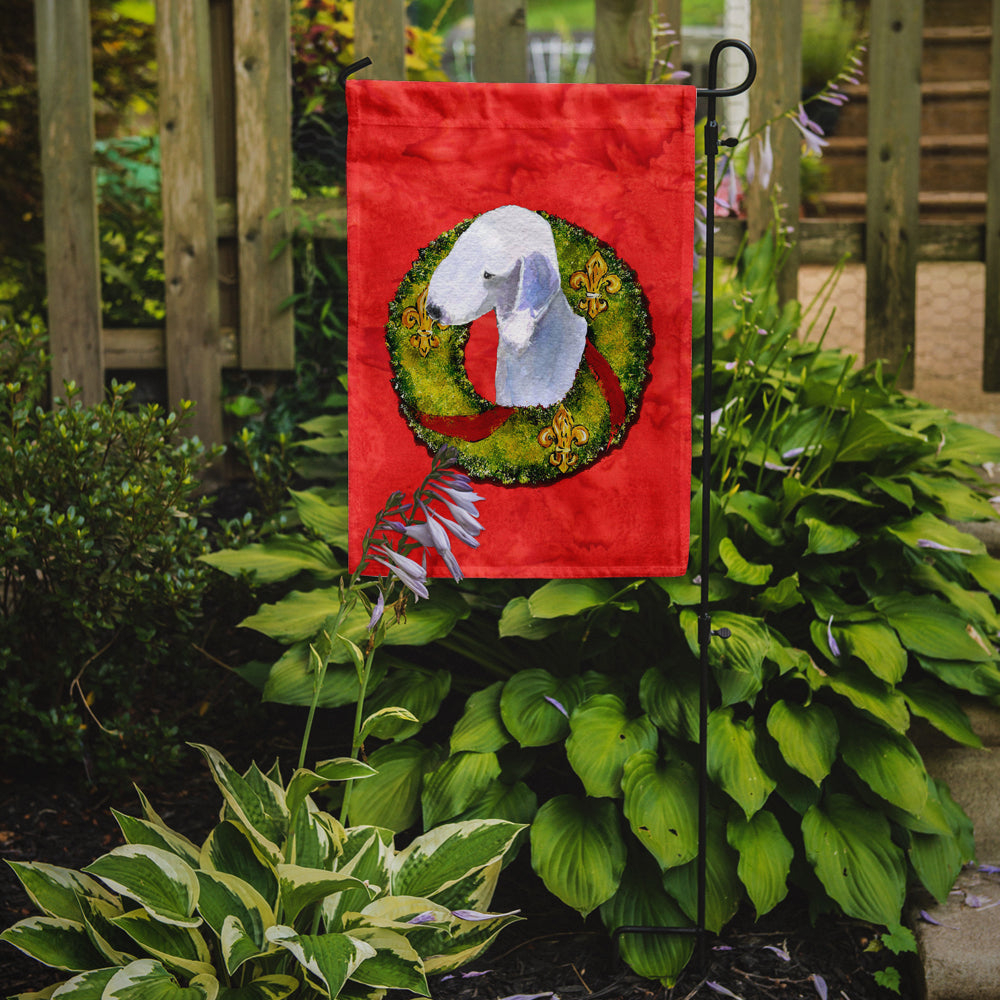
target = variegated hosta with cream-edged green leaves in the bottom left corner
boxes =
[0,746,521,1000]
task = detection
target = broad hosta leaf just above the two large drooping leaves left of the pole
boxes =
[566,694,659,799]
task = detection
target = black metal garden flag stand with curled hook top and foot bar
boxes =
[612,38,757,971]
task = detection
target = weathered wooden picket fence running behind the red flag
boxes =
[35,0,1000,441]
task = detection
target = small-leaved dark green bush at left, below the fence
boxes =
[0,321,220,776]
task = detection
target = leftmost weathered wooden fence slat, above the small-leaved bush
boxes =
[35,0,104,405]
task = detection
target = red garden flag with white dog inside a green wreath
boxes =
[347,80,695,577]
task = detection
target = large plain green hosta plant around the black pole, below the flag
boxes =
[342,232,1000,982]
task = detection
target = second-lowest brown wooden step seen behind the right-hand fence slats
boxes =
[823,135,988,191]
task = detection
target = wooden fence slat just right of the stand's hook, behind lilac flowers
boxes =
[748,0,802,301]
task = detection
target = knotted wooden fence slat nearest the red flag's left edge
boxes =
[233,0,295,369]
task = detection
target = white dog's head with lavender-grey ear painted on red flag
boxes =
[427,205,560,353]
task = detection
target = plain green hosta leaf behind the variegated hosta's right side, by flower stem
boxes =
[350,740,439,833]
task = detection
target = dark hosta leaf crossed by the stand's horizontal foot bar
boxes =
[601,857,694,987]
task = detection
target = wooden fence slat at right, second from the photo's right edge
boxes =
[865,0,924,389]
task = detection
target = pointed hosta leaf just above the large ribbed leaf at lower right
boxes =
[840,718,927,815]
